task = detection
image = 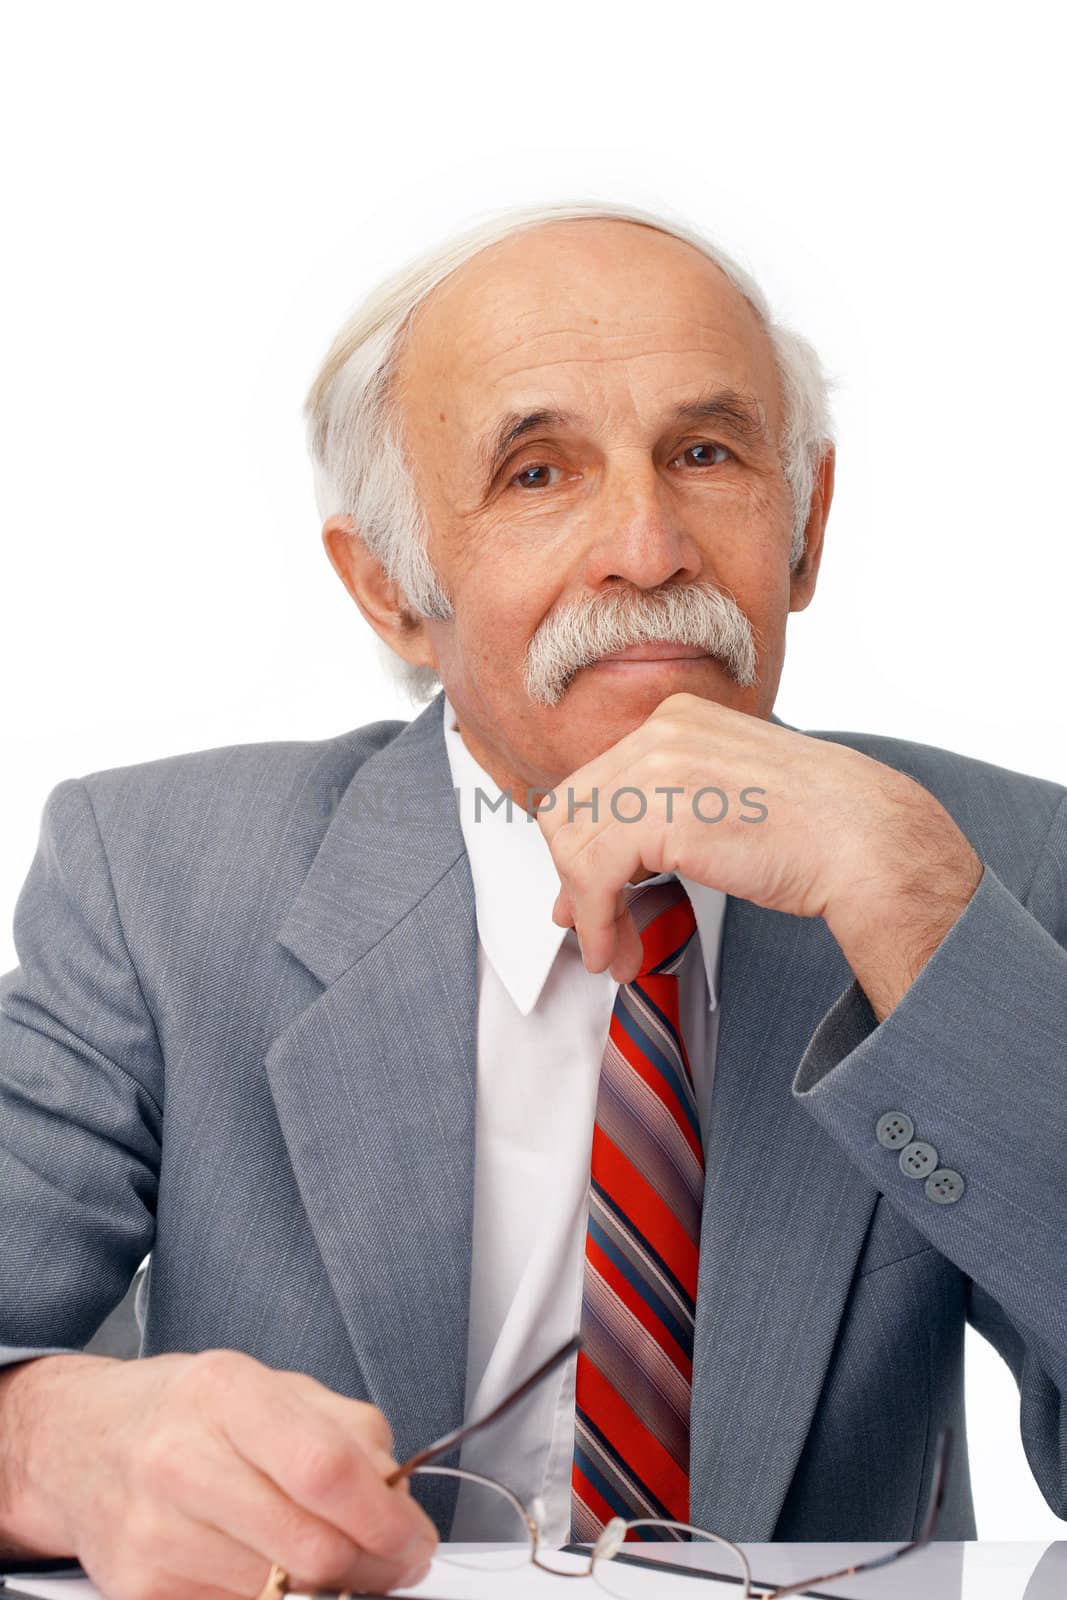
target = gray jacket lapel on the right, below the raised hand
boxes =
[689,717,878,1541]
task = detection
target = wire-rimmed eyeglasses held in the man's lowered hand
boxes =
[281,1336,952,1600]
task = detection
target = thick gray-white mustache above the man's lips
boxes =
[525,582,757,706]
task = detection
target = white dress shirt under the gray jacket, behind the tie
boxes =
[445,696,726,1544]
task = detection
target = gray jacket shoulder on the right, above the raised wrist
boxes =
[797,728,1067,880]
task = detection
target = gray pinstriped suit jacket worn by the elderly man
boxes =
[0,694,1067,1541]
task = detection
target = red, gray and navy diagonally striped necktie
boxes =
[571,878,704,1542]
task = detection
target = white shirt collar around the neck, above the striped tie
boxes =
[443,694,726,1016]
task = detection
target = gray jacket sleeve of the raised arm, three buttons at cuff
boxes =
[792,797,1067,1517]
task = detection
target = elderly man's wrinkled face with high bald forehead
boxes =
[329,221,832,789]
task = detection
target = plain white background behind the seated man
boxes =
[0,0,1067,1539]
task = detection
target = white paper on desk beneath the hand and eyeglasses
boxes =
[0,1550,748,1600]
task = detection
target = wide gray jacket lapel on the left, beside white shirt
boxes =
[266,694,477,1504]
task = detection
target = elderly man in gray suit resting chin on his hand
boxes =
[0,205,1067,1597]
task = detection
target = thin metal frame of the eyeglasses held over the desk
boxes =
[278,1334,953,1600]
